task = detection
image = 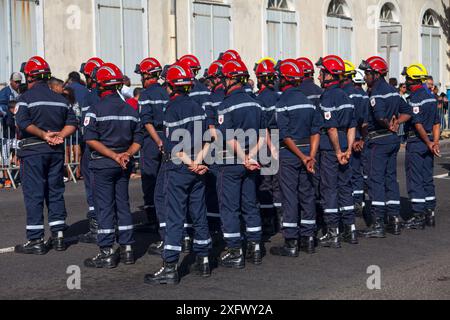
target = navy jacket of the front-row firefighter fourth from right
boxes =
[276,87,323,156]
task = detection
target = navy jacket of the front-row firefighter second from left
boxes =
[84,93,143,169]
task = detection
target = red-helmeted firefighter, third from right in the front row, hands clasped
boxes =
[316,55,358,248]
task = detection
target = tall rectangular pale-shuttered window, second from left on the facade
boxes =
[96,0,148,85]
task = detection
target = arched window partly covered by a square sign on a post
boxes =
[378,2,402,79]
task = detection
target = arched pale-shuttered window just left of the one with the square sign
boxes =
[326,0,353,60]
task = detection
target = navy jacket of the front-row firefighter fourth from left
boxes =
[218,88,266,161]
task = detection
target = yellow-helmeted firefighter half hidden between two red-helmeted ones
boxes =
[341,61,369,216]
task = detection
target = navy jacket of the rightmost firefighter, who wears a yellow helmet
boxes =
[406,88,441,151]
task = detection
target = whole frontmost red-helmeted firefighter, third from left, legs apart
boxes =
[144,63,212,284]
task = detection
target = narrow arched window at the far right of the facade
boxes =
[421,9,441,82]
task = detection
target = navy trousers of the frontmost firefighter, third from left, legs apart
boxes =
[163,165,212,263]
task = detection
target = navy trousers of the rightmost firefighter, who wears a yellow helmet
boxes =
[406,142,436,214]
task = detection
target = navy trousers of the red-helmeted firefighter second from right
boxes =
[367,142,400,219]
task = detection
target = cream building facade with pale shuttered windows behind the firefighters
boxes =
[0,0,450,90]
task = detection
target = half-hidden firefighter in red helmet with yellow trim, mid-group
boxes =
[254,58,281,236]
